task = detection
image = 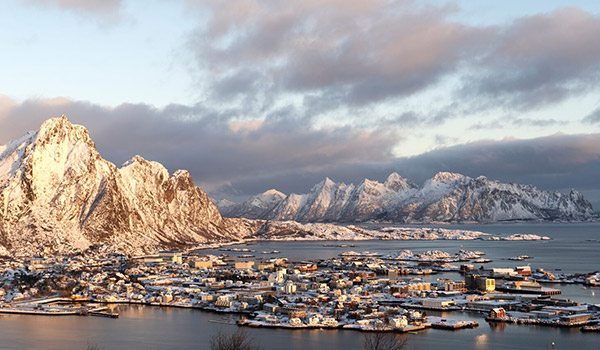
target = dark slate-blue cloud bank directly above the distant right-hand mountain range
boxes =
[224,134,600,208]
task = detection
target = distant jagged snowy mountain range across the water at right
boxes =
[217,172,595,223]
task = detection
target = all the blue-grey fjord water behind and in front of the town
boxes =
[0,223,600,350]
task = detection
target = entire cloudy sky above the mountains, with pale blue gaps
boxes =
[0,0,600,210]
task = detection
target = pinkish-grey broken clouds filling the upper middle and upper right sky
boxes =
[189,0,600,121]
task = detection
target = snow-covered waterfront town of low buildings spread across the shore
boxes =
[0,246,600,332]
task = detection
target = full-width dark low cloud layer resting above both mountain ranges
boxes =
[0,99,600,207]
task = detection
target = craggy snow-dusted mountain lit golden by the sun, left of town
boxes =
[0,116,257,255]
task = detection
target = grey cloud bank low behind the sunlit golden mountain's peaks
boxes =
[0,95,400,193]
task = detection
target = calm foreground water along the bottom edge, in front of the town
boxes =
[0,306,600,350]
